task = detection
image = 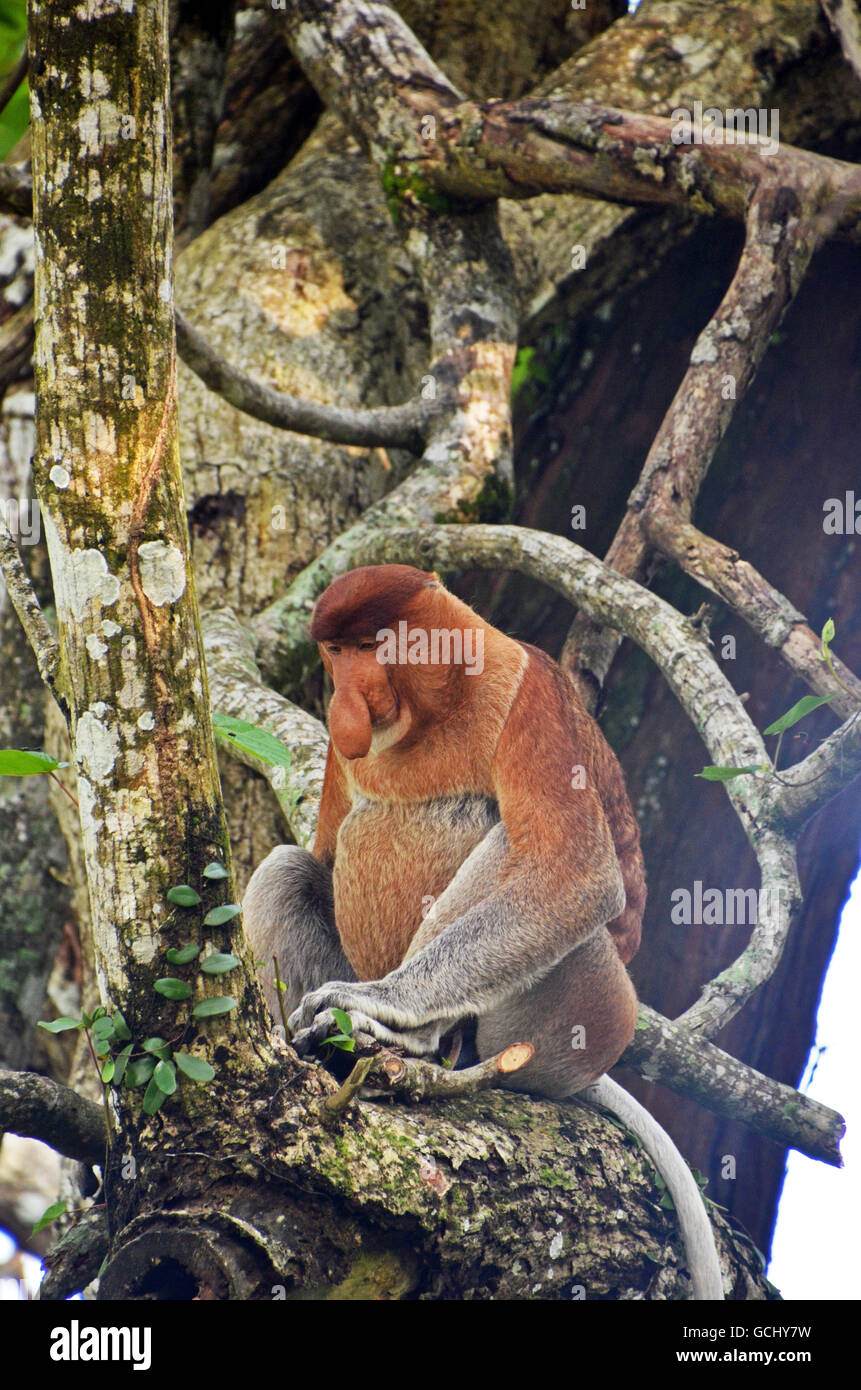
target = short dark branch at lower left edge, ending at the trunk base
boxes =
[0,1069,107,1163]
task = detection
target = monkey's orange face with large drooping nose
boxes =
[320,637,412,759]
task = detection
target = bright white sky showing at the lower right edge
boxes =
[768,873,861,1300]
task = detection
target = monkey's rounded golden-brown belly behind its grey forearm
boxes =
[334,795,499,980]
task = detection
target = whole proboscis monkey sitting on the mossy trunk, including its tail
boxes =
[245,564,723,1298]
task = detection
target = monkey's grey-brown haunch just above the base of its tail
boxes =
[476,927,637,1099]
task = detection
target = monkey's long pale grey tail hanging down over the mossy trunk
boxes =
[579,1076,723,1301]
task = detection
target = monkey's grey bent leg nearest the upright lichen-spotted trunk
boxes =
[242,845,355,1020]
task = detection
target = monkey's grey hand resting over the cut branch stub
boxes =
[288,980,448,1056]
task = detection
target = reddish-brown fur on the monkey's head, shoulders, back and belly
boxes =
[312,566,645,1073]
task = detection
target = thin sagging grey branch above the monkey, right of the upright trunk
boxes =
[177,310,433,453]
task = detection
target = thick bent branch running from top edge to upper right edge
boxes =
[279,0,861,228]
